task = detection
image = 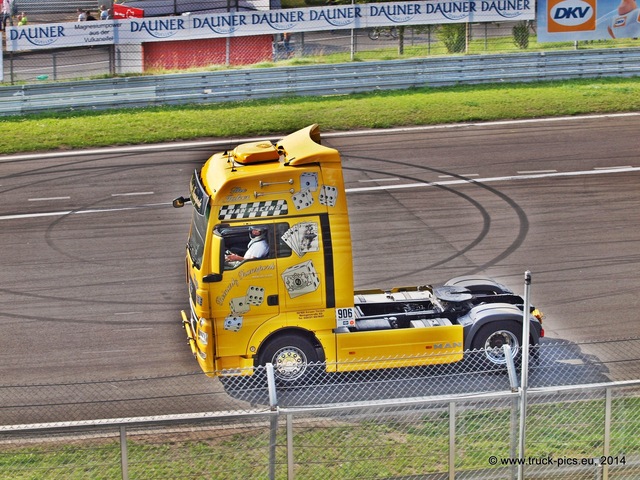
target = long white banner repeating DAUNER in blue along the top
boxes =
[6,0,535,51]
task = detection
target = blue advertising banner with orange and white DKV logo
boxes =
[537,0,640,42]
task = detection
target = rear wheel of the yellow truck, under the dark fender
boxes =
[471,320,522,370]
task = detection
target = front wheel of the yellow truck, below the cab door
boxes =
[258,333,319,385]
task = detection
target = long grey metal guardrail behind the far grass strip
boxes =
[0,48,640,115]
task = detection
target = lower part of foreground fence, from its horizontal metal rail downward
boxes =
[0,381,640,480]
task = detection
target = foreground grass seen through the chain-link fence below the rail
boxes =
[0,397,640,480]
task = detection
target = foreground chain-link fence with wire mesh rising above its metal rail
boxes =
[0,339,640,479]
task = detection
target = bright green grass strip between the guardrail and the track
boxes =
[0,78,640,154]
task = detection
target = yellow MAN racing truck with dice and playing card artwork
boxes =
[173,125,543,384]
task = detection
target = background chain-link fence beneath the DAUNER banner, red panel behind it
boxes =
[4,22,528,83]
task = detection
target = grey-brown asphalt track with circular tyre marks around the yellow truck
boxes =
[0,115,640,416]
